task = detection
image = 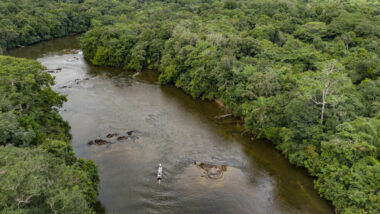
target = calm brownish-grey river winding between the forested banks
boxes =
[6,37,333,214]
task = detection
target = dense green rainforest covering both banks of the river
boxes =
[0,0,380,213]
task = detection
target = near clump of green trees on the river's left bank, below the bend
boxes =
[0,56,99,213]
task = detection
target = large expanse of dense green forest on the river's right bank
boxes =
[81,0,380,213]
